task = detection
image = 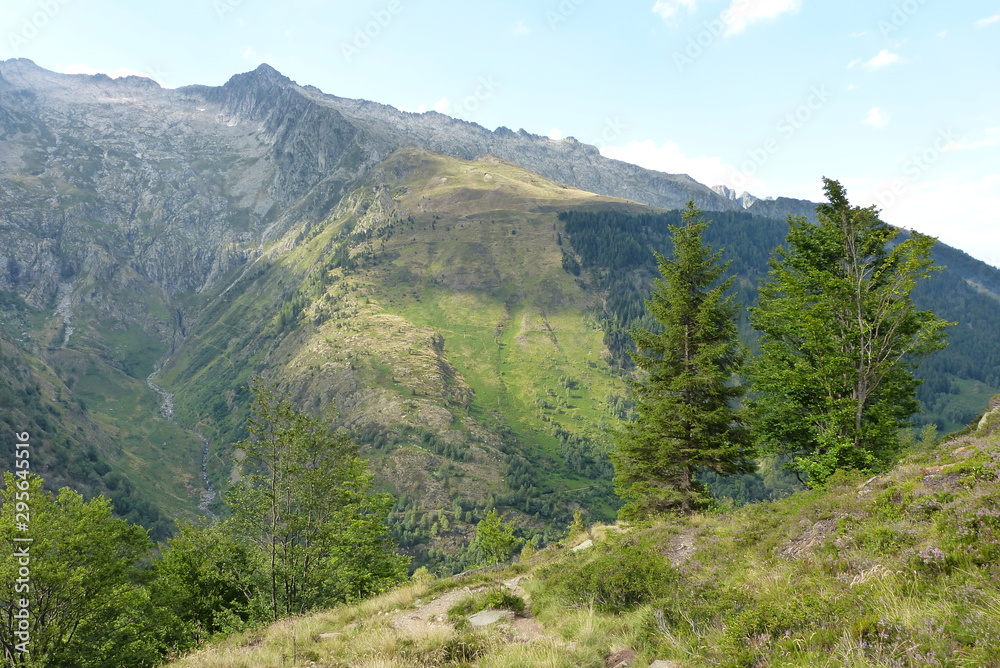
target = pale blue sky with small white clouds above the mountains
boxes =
[0,0,1000,265]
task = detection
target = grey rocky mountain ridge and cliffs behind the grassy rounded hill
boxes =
[0,59,812,306]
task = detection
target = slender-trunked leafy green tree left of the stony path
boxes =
[226,380,408,619]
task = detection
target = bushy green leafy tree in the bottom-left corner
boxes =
[0,473,165,668]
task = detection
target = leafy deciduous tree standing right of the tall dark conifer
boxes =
[750,179,949,486]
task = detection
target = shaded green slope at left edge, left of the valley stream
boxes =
[0,293,178,538]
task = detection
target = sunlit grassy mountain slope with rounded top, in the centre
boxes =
[157,149,652,568]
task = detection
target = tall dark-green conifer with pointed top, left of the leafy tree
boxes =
[613,202,753,519]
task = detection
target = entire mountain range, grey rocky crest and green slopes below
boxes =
[0,59,1000,563]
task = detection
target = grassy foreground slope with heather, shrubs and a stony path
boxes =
[164,397,1000,668]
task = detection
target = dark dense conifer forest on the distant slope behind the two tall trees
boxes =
[559,210,1000,431]
